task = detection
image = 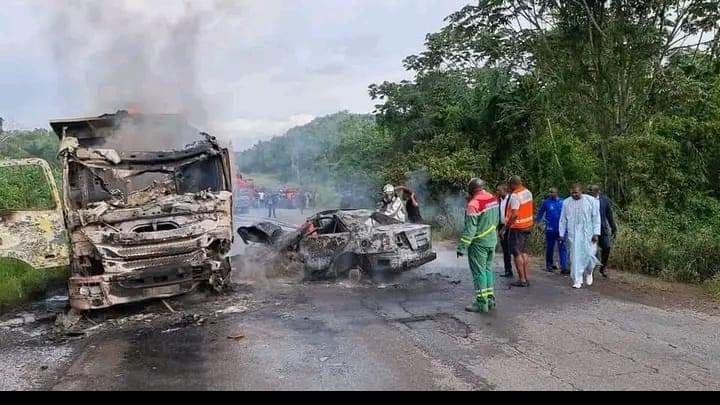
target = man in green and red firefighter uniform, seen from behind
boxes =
[457,178,500,312]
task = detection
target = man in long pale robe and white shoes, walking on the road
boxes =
[559,184,600,288]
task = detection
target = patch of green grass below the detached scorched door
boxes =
[0,258,68,312]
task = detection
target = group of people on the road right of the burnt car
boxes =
[457,176,617,312]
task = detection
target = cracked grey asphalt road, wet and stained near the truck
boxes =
[0,207,720,390]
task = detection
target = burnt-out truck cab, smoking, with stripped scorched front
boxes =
[50,111,233,310]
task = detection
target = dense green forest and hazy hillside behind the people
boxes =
[240,0,720,282]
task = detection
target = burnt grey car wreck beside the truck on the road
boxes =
[237,210,437,281]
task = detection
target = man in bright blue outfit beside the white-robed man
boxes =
[535,187,570,274]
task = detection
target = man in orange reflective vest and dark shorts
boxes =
[501,176,535,287]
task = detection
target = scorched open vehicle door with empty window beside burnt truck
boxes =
[0,159,69,269]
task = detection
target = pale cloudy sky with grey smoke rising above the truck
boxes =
[0,0,468,149]
